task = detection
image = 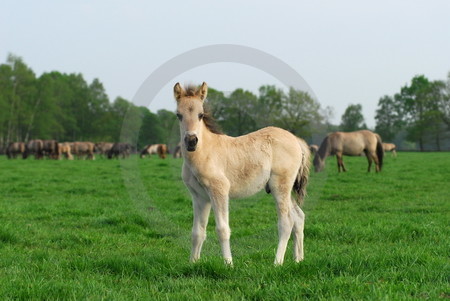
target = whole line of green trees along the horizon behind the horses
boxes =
[0,54,450,150]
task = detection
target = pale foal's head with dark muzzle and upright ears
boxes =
[173,82,208,152]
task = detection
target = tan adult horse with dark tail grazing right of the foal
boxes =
[314,130,384,172]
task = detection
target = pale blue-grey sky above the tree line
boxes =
[0,0,450,127]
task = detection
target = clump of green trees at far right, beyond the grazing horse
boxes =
[375,73,450,151]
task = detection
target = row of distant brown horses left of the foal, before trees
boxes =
[6,139,181,160]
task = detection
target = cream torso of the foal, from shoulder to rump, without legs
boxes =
[205,127,302,198]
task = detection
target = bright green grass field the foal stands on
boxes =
[0,153,450,300]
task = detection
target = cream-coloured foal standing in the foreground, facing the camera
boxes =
[174,83,310,265]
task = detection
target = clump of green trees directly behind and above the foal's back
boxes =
[208,85,323,137]
